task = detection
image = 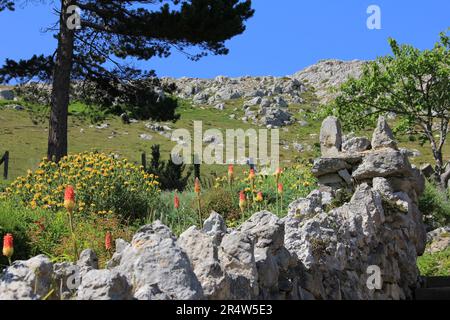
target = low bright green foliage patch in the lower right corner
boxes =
[417,248,450,277]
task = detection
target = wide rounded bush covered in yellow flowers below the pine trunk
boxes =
[0,152,159,218]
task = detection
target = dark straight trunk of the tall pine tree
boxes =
[47,0,74,162]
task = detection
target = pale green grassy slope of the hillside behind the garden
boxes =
[0,90,450,184]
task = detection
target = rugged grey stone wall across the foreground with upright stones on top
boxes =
[0,118,426,300]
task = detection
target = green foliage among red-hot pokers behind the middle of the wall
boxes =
[146,164,317,234]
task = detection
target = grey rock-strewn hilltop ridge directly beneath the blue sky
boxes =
[164,60,364,127]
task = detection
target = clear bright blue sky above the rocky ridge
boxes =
[0,0,450,77]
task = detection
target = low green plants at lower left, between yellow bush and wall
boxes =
[0,201,136,266]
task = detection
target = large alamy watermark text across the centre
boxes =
[171,121,280,169]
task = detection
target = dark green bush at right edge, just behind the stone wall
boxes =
[419,182,450,229]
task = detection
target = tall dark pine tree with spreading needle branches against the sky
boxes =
[0,0,254,159]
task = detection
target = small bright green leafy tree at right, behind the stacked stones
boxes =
[327,32,450,183]
